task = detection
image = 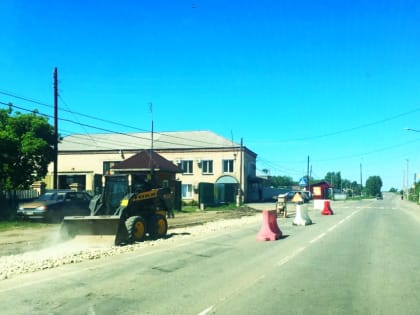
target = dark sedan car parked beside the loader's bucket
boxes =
[17,190,91,222]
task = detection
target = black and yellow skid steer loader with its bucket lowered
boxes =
[60,188,172,245]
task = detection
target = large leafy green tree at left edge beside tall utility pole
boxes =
[0,107,54,190]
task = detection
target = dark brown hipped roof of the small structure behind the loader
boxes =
[113,150,182,173]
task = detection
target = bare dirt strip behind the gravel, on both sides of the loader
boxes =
[0,207,259,256]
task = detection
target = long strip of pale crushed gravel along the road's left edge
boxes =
[0,215,261,281]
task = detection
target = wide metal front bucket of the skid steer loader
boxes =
[60,215,128,245]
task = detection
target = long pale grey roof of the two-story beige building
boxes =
[58,131,240,152]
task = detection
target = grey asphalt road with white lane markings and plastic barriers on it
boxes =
[0,194,420,315]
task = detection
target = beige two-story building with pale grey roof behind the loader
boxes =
[45,131,262,203]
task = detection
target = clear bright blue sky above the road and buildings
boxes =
[0,0,420,190]
